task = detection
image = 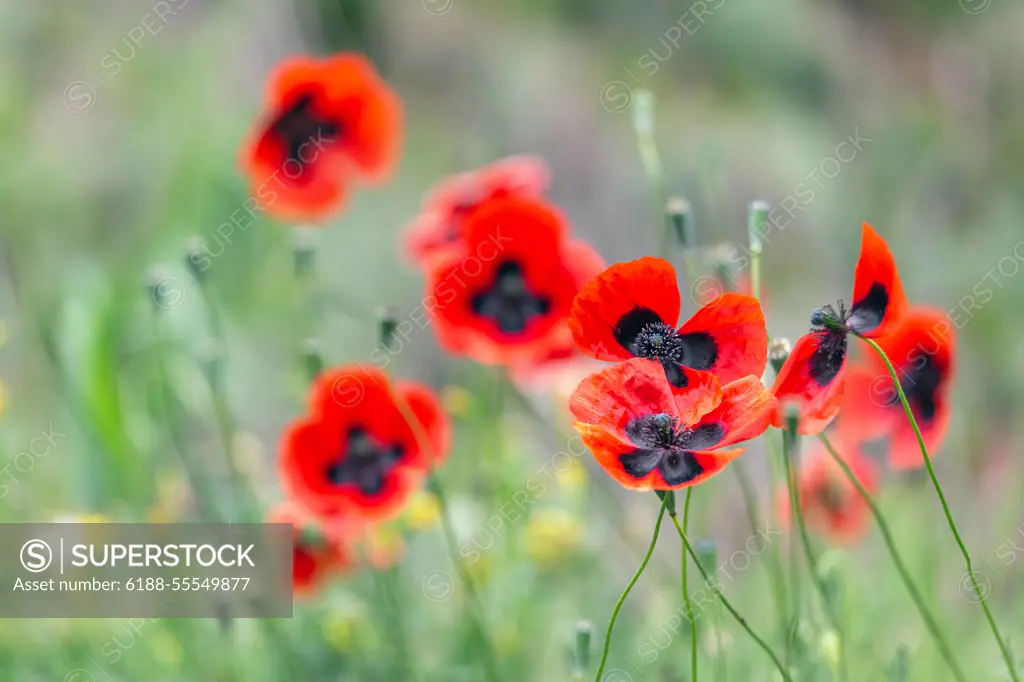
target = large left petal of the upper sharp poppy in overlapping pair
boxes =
[569,257,682,360]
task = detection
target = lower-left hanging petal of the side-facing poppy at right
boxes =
[771,332,847,435]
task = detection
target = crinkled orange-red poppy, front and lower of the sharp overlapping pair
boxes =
[569,358,775,491]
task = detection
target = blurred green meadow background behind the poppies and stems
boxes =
[0,0,1024,682]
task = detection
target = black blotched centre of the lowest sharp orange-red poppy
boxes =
[618,414,725,485]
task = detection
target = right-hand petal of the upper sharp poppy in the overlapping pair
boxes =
[679,293,768,384]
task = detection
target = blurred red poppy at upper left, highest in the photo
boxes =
[242,53,401,222]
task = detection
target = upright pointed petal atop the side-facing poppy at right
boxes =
[847,222,907,338]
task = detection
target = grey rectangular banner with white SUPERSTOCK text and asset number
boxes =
[0,523,293,619]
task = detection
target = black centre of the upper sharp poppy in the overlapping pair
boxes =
[612,306,718,388]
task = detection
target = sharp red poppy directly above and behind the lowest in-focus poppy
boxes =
[569,257,768,387]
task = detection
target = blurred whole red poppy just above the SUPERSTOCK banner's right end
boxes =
[280,366,451,523]
